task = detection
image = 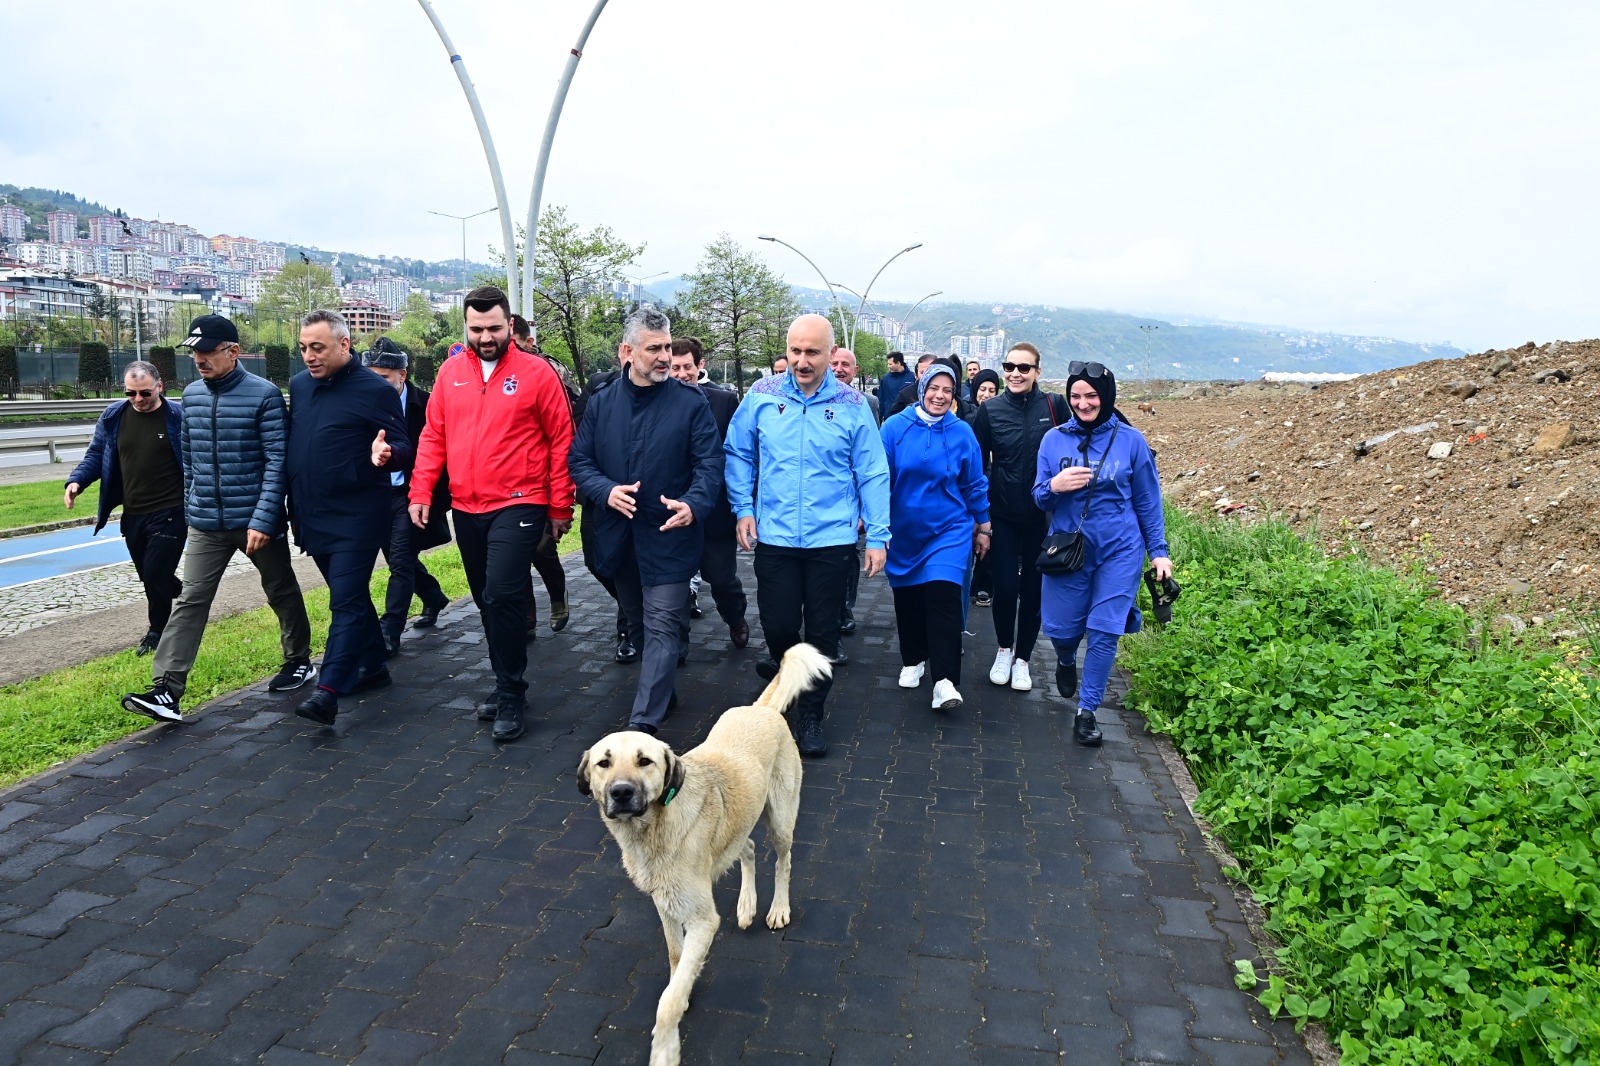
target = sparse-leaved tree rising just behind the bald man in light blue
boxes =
[682,234,800,394]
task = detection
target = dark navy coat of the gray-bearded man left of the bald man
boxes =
[566,375,723,584]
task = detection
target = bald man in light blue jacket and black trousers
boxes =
[723,315,890,755]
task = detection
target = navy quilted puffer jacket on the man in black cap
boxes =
[184,367,290,536]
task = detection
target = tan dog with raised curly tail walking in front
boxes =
[578,643,832,1066]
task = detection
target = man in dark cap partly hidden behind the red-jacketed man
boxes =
[362,336,450,646]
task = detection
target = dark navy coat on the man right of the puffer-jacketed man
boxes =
[288,359,413,555]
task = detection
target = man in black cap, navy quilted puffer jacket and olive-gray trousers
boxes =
[122,315,317,722]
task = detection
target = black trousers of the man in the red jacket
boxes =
[456,504,547,696]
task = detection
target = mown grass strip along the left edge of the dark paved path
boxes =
[0,515,579,787]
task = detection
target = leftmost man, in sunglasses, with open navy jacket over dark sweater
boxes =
[64,360,187,655]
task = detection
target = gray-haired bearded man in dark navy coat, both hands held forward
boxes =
[568,306,723,733]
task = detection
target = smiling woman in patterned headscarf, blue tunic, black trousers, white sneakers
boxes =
[882,362,992,709]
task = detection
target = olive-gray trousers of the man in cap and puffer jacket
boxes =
[150,527,310,696]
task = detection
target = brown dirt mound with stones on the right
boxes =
[1128,339,1600,613]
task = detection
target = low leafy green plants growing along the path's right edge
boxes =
[1123,515,1600,1066]
